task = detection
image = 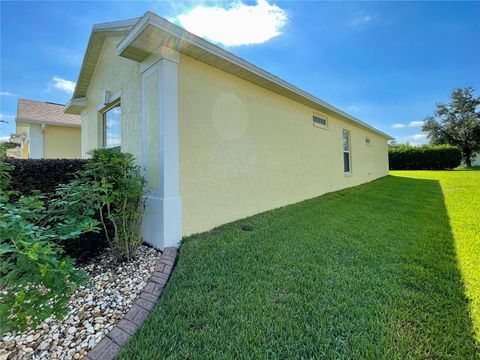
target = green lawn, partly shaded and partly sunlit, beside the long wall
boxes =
[119,171,480,359]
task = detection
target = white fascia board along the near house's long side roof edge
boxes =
[117,12,393,140]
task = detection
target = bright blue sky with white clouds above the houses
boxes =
[0,0,480,143]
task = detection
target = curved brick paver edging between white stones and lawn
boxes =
[86,247,177,360]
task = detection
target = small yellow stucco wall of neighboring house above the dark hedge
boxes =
[43,125,81,159]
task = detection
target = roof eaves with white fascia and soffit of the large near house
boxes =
[65,12,393,139]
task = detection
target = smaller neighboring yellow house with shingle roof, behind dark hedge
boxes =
[9,99,81,159]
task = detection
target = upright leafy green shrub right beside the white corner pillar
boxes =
[69,149,145,261]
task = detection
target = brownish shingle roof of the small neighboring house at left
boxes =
[16,99,81,127]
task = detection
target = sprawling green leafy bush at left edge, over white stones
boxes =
[0,162,98,333]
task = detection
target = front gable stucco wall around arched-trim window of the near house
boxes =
[81,37,142,158]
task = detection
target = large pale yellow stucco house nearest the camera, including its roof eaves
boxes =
[65,12,391,248]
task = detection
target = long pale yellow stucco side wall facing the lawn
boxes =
[179,52,388,235]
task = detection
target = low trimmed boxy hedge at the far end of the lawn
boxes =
[388,145,462,170]
